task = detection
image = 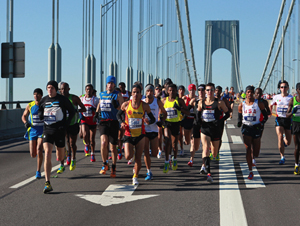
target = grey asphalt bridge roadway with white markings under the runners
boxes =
[0,107,300,226]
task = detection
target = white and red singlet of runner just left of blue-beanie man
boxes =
[80,96,99,125]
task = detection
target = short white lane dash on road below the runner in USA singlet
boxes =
[240,162,266,188]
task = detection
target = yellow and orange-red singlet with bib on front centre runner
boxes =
[124,100,145,137]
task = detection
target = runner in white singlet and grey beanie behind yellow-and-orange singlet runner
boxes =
[142,84,167,180]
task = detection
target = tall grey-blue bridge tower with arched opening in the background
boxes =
[204,20,243,91]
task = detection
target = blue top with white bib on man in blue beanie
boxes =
[100,90,119,120]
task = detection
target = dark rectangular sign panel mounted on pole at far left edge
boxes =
[1,42,25,78]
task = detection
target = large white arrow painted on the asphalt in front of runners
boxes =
[76,184,158,206]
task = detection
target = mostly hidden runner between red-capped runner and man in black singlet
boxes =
[188,84,205,167]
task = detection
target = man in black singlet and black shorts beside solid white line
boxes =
[198,83,229,182]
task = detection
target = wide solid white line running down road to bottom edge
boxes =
[219,129,248,226]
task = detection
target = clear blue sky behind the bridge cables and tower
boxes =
[0,0,298,101]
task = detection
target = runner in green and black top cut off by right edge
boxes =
[286,83,300,175]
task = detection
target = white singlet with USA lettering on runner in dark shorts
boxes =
[242,99,261,126]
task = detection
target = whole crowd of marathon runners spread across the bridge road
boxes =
[22,76,300,193]
